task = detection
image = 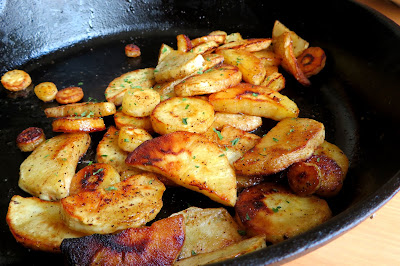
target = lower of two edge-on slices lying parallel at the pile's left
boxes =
[51,116,106,133]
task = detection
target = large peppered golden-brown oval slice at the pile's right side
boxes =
[233,118,325,176]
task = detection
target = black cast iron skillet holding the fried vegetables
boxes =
[0,0,400,265]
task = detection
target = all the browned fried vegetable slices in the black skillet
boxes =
[2,21,348,265]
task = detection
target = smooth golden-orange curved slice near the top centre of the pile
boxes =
[217,49,266,85]
